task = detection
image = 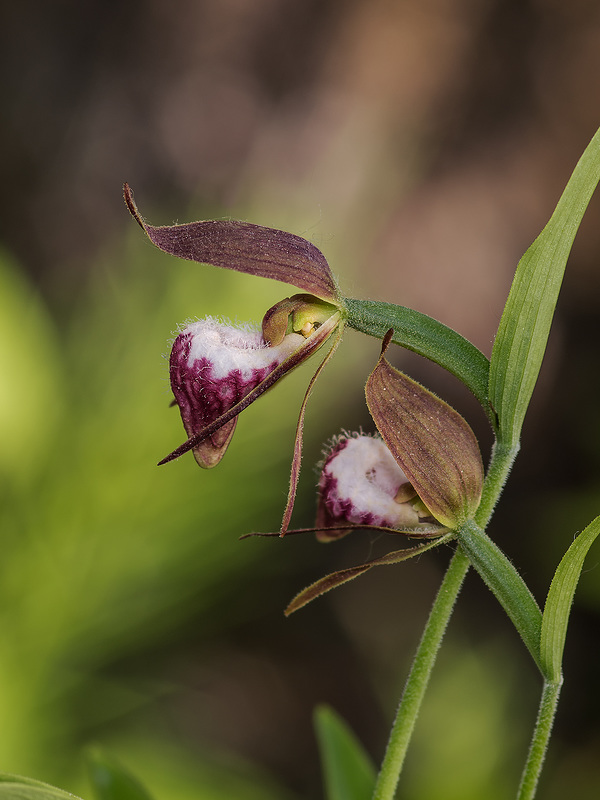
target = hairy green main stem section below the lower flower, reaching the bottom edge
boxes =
[373,550,469,800]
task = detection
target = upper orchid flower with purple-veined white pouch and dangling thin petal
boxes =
[124,184,346,535]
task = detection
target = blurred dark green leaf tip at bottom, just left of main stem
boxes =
[314,706,376,800]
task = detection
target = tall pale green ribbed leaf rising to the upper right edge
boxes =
[489,130,600,444]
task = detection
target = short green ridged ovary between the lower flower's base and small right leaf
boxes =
[456,520,542,669]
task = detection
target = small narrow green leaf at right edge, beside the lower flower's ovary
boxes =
[540,517,600,681]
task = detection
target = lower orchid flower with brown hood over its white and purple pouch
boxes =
[286,331,483,614]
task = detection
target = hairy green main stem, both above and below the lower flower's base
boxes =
[373,444,518,800]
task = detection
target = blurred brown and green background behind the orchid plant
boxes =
[0,0,600,800]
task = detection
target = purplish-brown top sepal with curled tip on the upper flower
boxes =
[123,184,338,302]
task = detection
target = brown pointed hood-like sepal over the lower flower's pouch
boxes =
[366,331,483,528]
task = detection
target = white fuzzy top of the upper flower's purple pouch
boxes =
[180,317,304,380]
